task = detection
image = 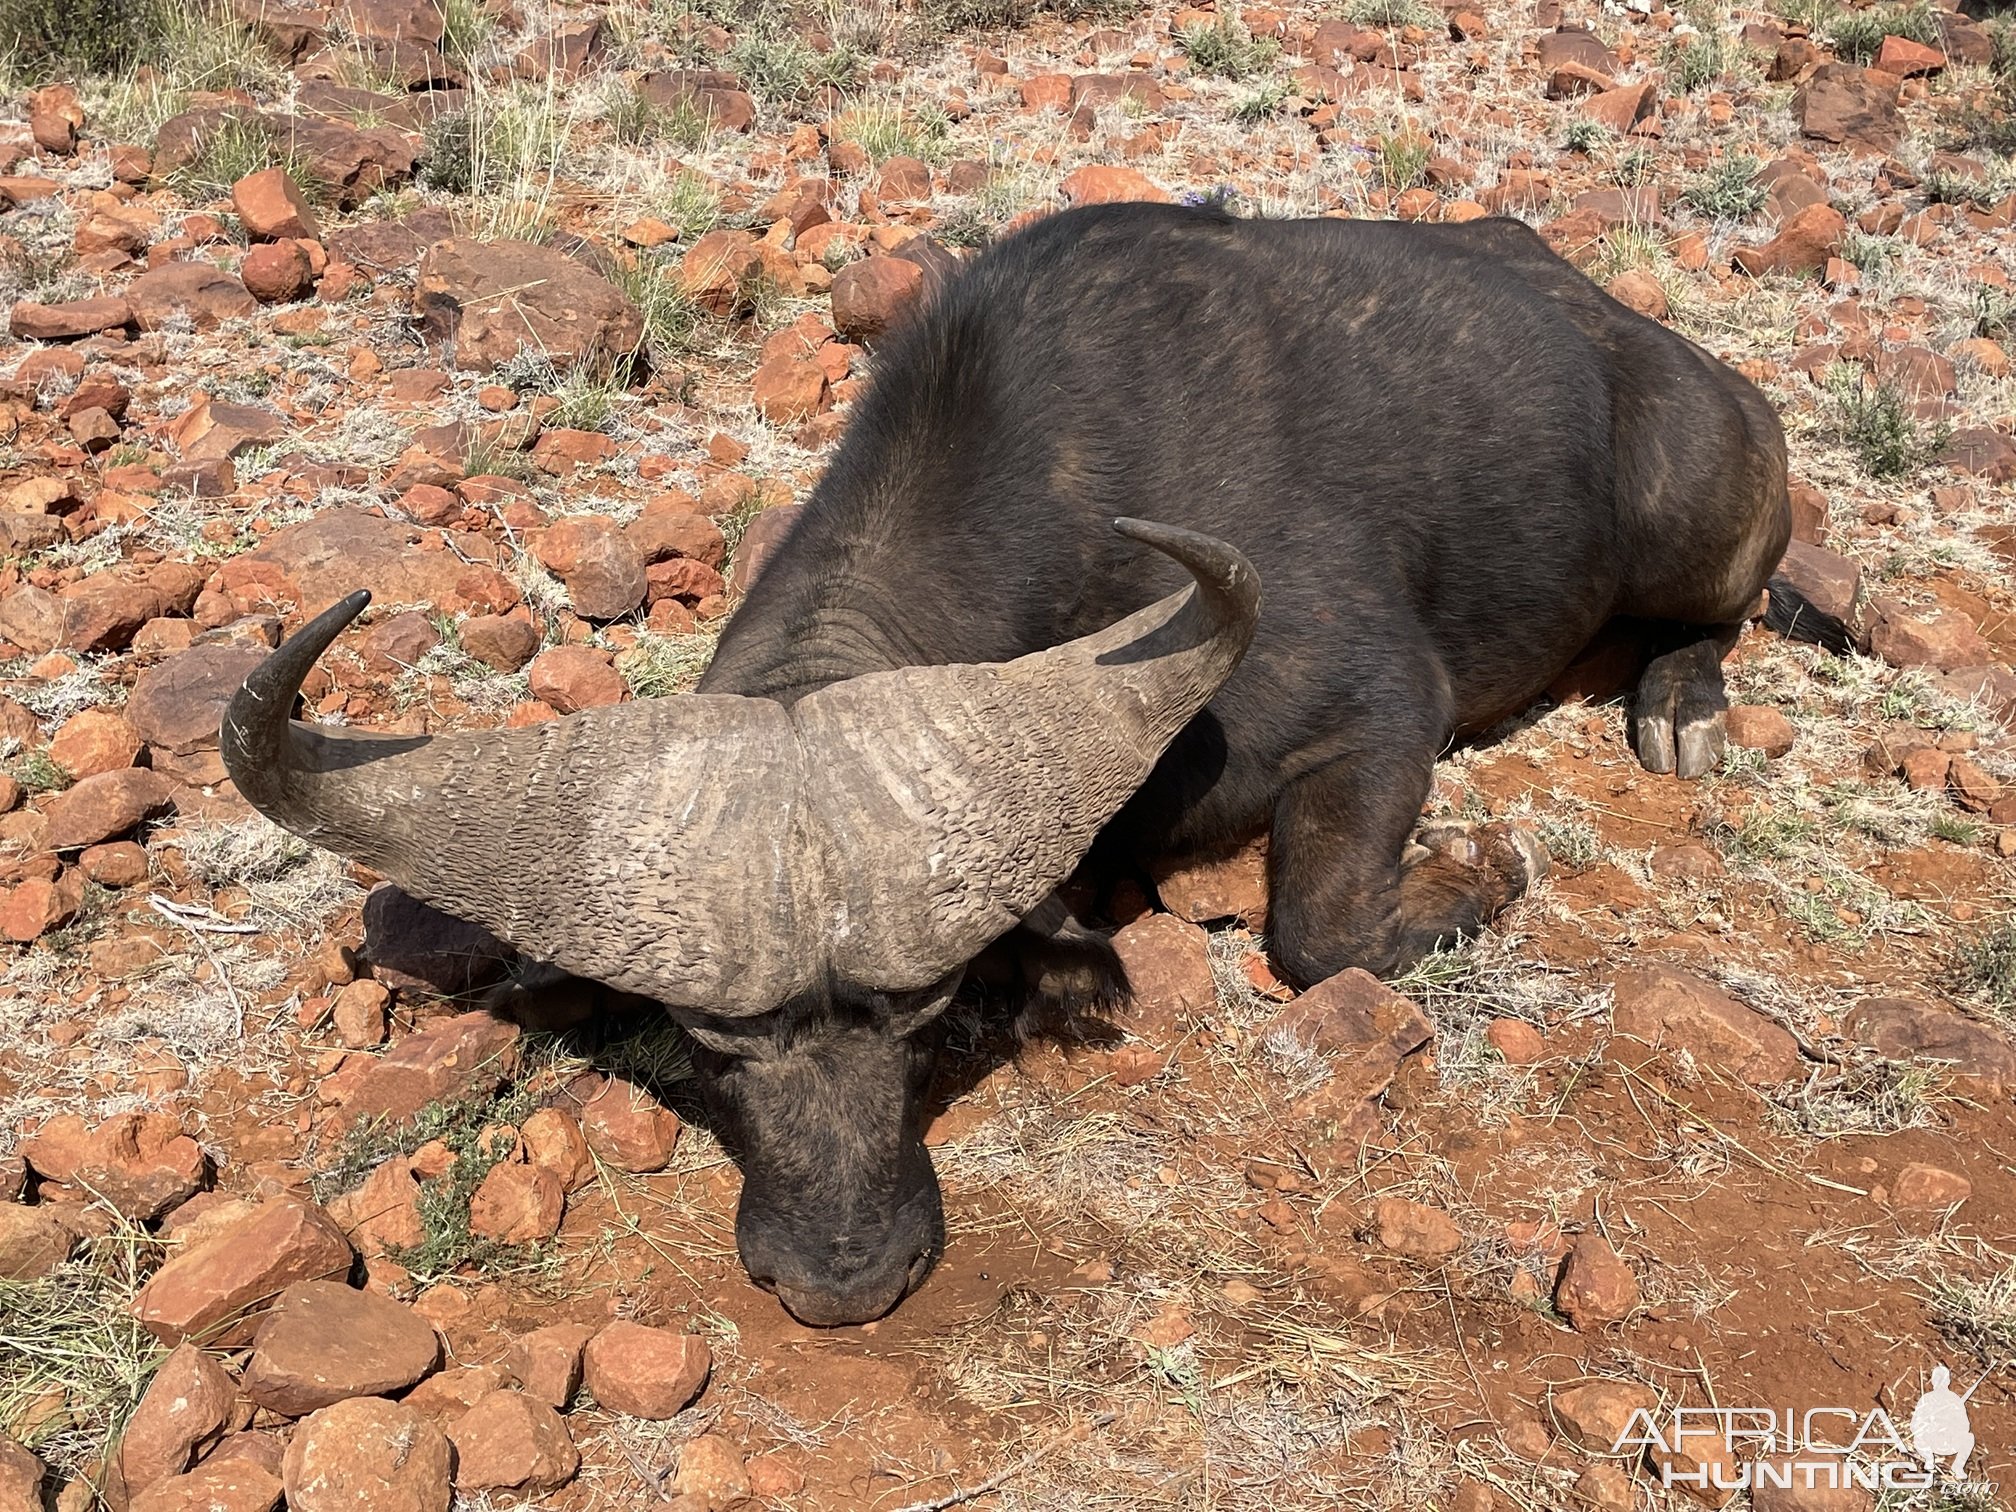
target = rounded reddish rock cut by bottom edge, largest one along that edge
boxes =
[284,1397,456,1512]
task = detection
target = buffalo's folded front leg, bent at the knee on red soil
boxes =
[1268,742,1546,986]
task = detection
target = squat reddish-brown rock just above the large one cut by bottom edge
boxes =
[244,1280,442,1417]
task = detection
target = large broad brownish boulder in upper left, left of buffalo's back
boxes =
[413,236,643,373]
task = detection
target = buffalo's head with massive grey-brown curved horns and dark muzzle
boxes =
[222,520,1260,1325]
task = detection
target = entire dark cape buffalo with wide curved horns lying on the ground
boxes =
[224,206,1790,1322]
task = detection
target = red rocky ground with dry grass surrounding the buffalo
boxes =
[0,0,2016,1512]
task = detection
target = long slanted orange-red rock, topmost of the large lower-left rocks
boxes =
[133,1198,353,1347]
